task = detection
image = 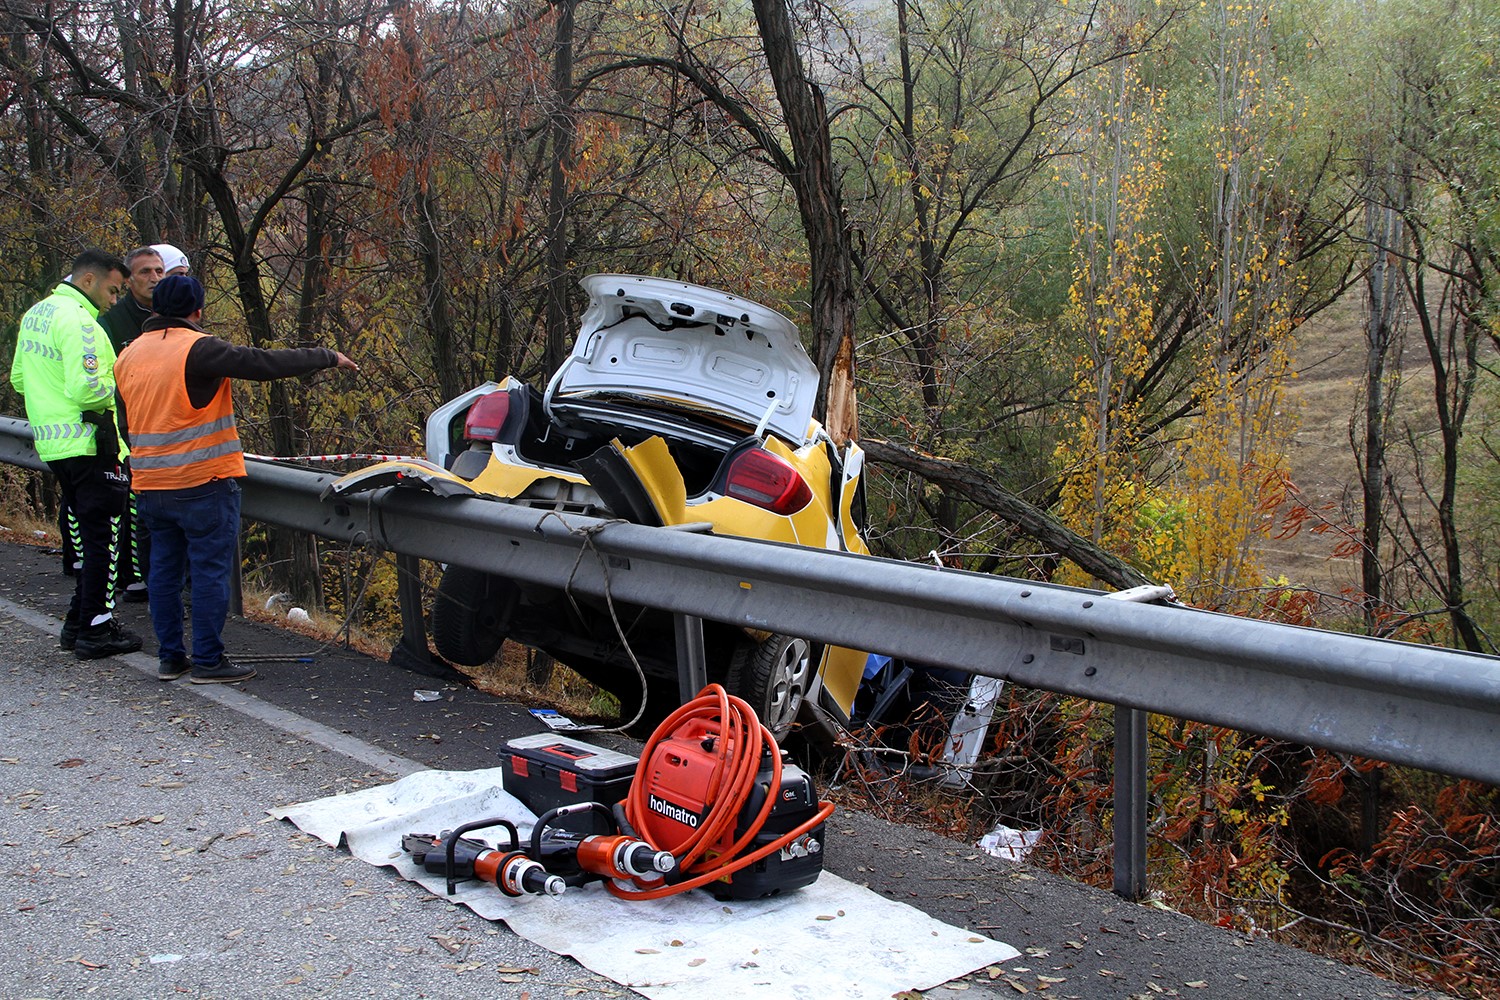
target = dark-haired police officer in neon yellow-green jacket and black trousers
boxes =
[11,250,141,660]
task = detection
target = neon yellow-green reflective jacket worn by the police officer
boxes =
[11,282,123,462]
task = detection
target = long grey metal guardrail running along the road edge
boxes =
[0,418,1500,895]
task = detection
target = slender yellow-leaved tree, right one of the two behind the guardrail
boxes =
[1169,3,1302,607]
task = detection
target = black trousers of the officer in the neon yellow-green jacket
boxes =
[47,454,131,628]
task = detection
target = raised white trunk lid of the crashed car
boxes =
[548,274,818,445]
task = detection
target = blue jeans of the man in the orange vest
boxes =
[137,480,240,667]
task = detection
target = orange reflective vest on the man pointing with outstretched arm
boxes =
[116,327,245,490]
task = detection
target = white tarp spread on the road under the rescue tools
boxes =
[270,768,1017,1000]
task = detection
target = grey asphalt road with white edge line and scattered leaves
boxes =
[0,544,1439,1000]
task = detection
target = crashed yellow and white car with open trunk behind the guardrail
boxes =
[333,274,869,738]
